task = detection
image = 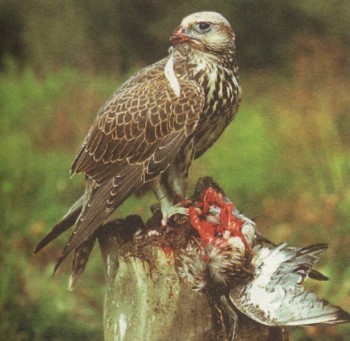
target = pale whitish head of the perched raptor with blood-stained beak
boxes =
[170,12,235,54]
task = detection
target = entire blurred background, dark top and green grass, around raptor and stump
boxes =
[0,0,350,340]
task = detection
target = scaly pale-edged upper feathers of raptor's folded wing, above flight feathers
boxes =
[71,79,203,184]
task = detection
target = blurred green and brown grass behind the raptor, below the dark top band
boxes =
[0,48,350,340]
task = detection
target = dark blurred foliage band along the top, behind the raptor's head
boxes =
[0,0,350,73]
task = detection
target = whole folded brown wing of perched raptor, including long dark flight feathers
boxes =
[56,76,204,268]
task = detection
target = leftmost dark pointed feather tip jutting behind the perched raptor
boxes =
[34,197,83,253]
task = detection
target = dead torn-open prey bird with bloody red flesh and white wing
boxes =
[178,187,350,332]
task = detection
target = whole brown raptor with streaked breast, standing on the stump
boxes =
[35,12,241,286]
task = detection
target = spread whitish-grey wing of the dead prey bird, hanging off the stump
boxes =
[229,244,350,326]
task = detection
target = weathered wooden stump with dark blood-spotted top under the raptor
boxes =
[98,177,288,341]
